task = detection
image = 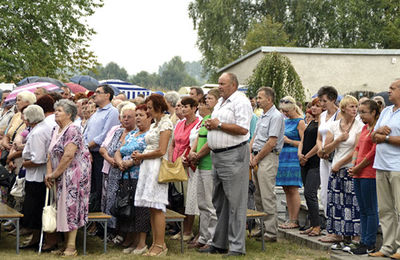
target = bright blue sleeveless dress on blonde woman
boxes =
[276,118,303,187]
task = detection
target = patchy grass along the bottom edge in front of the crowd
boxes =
[0,231,330,260]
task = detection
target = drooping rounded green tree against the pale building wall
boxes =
[247,52,305,105]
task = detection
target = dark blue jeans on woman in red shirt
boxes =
[353,178,378,246]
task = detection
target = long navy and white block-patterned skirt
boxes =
[326,168,361,236]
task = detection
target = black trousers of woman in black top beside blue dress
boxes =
[301,165,321,227]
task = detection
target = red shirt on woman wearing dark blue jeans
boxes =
[353,124,376,179]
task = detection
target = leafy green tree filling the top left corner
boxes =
[0,0,103,81]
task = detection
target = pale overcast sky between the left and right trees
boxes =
[87,0,201,75]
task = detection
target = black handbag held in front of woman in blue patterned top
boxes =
[110,173,135,218]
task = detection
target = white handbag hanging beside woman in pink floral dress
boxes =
[42,184,57,233]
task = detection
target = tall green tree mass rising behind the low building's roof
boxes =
[189,0,400,76]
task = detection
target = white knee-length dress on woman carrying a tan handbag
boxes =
[135,115,174,212]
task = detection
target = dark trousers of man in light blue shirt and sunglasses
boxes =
[89,152,104,212]
